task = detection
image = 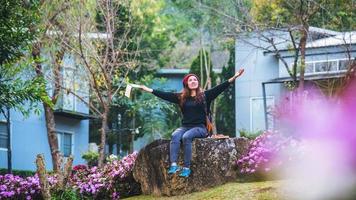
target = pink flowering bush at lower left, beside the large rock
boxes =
[0,153,141,200]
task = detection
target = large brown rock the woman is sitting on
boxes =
[133,138,248,196]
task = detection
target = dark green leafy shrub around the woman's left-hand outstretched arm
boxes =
[94,71,181,150]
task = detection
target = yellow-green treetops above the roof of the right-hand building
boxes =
[251,0,356,31]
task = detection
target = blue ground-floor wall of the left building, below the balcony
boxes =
[0,110,89,170]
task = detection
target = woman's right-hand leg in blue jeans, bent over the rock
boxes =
[183,127,207,169]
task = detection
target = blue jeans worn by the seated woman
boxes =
[170,125,207,168]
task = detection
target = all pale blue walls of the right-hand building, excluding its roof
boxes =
[235,31,356,136]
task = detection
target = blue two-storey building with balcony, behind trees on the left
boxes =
[0,55,89,170]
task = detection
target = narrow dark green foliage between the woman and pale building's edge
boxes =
[216,47,236,137]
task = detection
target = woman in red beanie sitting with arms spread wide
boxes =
[141,69,244,177]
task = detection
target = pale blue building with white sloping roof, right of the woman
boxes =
[235,27,356,136]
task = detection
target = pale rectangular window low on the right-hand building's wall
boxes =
[250,96,274,132]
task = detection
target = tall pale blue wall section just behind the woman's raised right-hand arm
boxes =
[235,38,281,136]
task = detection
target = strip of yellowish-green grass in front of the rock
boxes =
[127,181,282,200]
